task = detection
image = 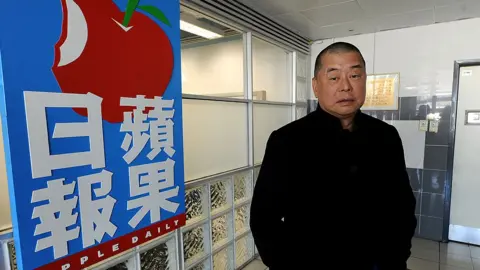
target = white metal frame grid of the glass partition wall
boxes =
[0,2,310,270]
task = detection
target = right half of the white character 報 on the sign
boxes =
[78,170,117,248]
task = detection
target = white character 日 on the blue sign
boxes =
[24,91,105,178]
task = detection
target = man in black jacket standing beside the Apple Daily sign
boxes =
[250,42,416,270]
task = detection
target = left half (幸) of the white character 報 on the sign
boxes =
[32,179,80,259]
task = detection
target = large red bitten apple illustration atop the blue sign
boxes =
[52,0,174,123]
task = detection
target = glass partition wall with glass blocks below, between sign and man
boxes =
[0,6,310,270]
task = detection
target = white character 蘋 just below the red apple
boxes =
[120,95,175,164]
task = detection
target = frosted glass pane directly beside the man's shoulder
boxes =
[253,104,292,163]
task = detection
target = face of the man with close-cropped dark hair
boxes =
[312,52,367,118]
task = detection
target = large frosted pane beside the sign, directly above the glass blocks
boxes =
[183,99,248,181]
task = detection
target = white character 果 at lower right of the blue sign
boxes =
[127,159,179,228]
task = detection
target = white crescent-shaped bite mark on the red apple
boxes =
[58,0,88,67]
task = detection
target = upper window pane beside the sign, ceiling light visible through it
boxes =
[180,6,244,98]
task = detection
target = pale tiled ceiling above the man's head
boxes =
[238,0,480,40]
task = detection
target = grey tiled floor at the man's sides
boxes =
[244,238,480,270]
